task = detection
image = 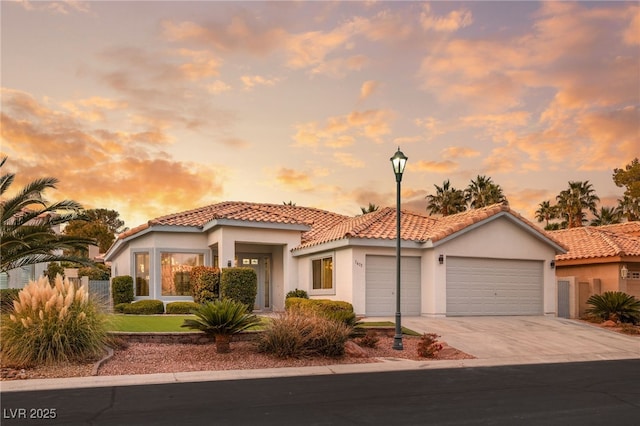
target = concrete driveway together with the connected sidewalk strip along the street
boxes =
[0,317,640,393]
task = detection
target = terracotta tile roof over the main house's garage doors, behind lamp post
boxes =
[298,204,563,249]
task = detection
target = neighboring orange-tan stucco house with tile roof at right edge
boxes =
[550,221,640,318]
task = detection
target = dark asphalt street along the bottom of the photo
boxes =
[1,359,640,426]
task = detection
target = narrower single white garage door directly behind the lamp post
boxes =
[365,256,420,316]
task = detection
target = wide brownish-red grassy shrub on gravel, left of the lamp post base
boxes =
[257,311,351,358]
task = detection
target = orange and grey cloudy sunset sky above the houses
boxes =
[0,1,640,227]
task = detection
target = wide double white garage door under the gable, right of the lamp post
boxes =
[446,257,544,316]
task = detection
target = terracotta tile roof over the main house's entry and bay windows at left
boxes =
[118,201,348,243]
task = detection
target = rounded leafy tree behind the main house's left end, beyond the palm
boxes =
[64,209,124,255]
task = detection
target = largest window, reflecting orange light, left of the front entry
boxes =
[160,253,204,296]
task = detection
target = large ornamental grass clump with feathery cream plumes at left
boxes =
[1,275,107,366]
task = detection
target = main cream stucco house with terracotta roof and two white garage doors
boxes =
[105,202,566,316]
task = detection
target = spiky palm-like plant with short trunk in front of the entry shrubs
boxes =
[181,299,260,353]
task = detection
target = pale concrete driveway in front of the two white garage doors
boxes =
[370,316,640,365]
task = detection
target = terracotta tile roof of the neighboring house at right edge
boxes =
[550,225,640,261]
